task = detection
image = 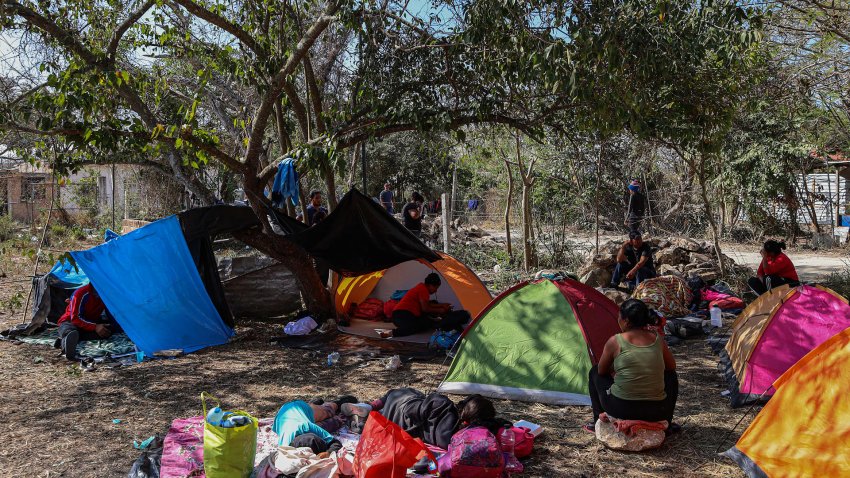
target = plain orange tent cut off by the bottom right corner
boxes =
[724,328,850,477]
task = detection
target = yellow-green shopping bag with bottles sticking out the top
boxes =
[201,392,258,478]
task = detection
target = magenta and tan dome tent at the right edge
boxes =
[721,285,850,406]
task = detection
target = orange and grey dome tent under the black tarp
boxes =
[334,252,493,317]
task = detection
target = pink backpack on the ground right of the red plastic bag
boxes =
[437,427,505,478]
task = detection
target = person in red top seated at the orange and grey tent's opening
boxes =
[380,272,470,338]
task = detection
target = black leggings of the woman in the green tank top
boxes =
[590,365,679,423]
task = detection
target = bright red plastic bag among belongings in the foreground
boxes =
[354,412,436,478]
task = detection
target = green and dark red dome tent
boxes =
[438,279,620,405]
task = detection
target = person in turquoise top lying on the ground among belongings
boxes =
[272,400,344,454]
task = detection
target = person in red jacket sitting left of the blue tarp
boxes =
[59,284,120,360]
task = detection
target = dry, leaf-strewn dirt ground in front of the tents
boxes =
[0,315,749,477]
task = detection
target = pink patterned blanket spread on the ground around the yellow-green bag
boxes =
[160,417,278,478]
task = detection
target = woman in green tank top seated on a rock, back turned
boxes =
[583,299,679,432]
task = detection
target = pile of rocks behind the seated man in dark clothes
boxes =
[578,237,747,287]
